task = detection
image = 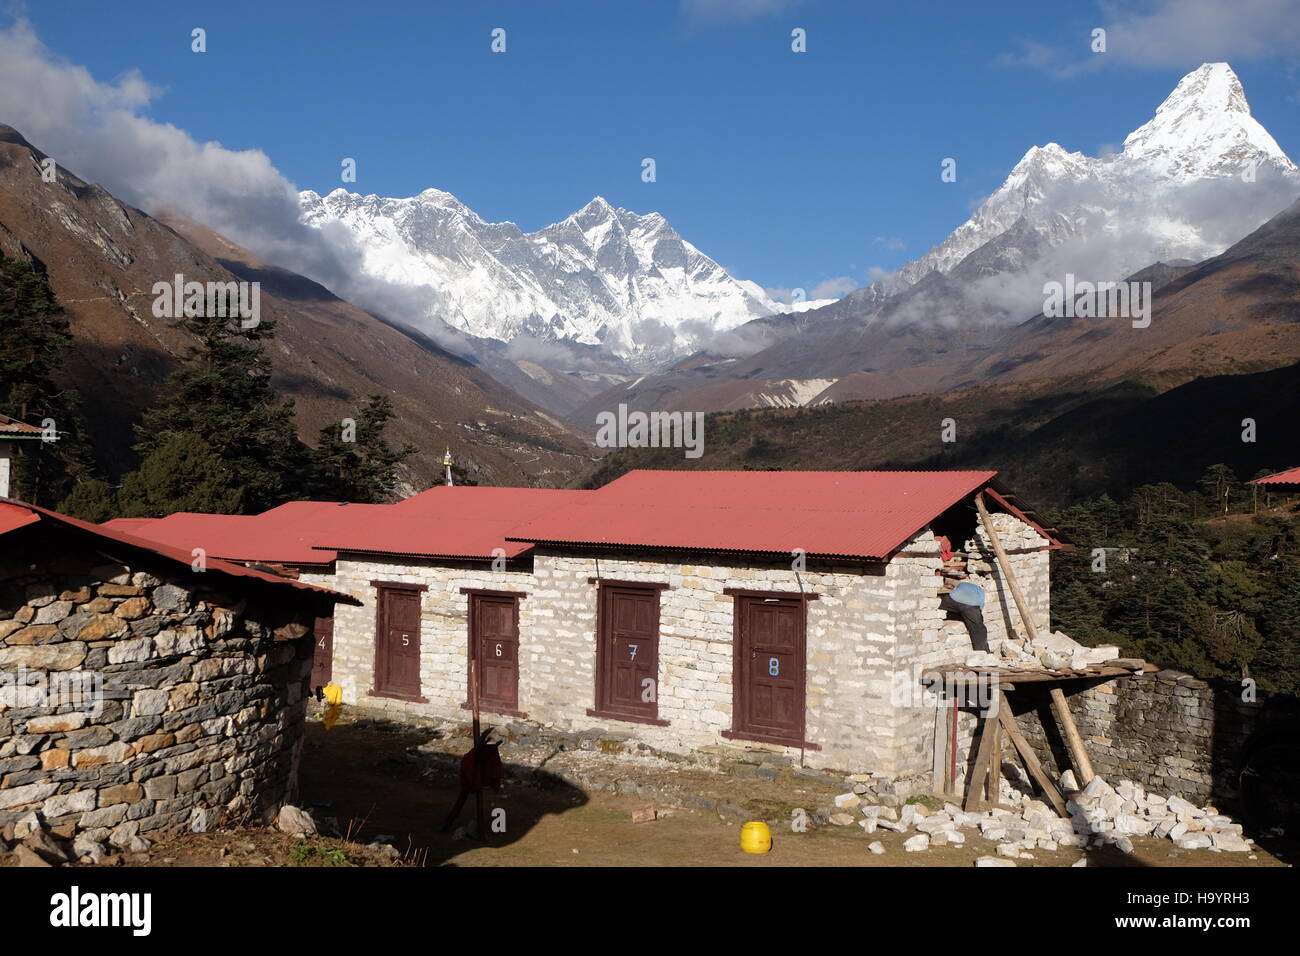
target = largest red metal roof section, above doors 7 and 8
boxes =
[508,471,997,559]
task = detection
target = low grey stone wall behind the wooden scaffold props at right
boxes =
[1008,670,1290,806]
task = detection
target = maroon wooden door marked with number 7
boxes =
[595,585,659,719]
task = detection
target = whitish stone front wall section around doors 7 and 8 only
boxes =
[521,548,896,767]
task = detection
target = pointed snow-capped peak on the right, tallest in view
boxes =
[885,62,1300,291]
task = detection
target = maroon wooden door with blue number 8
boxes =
[735,597,805,744]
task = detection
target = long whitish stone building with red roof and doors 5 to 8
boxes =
[116,471,1058,786]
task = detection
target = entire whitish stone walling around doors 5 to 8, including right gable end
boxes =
[319,515,1048,787]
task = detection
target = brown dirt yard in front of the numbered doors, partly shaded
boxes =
[289,722,1290,866]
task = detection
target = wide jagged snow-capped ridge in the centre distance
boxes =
[299,189,795,365]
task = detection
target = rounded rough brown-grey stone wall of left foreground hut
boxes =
[0,524,321,847]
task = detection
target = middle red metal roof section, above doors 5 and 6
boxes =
[317,485,594,558]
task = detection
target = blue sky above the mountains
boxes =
[10,0,1300,299]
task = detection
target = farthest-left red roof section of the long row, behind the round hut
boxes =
[104,501,391,564]
